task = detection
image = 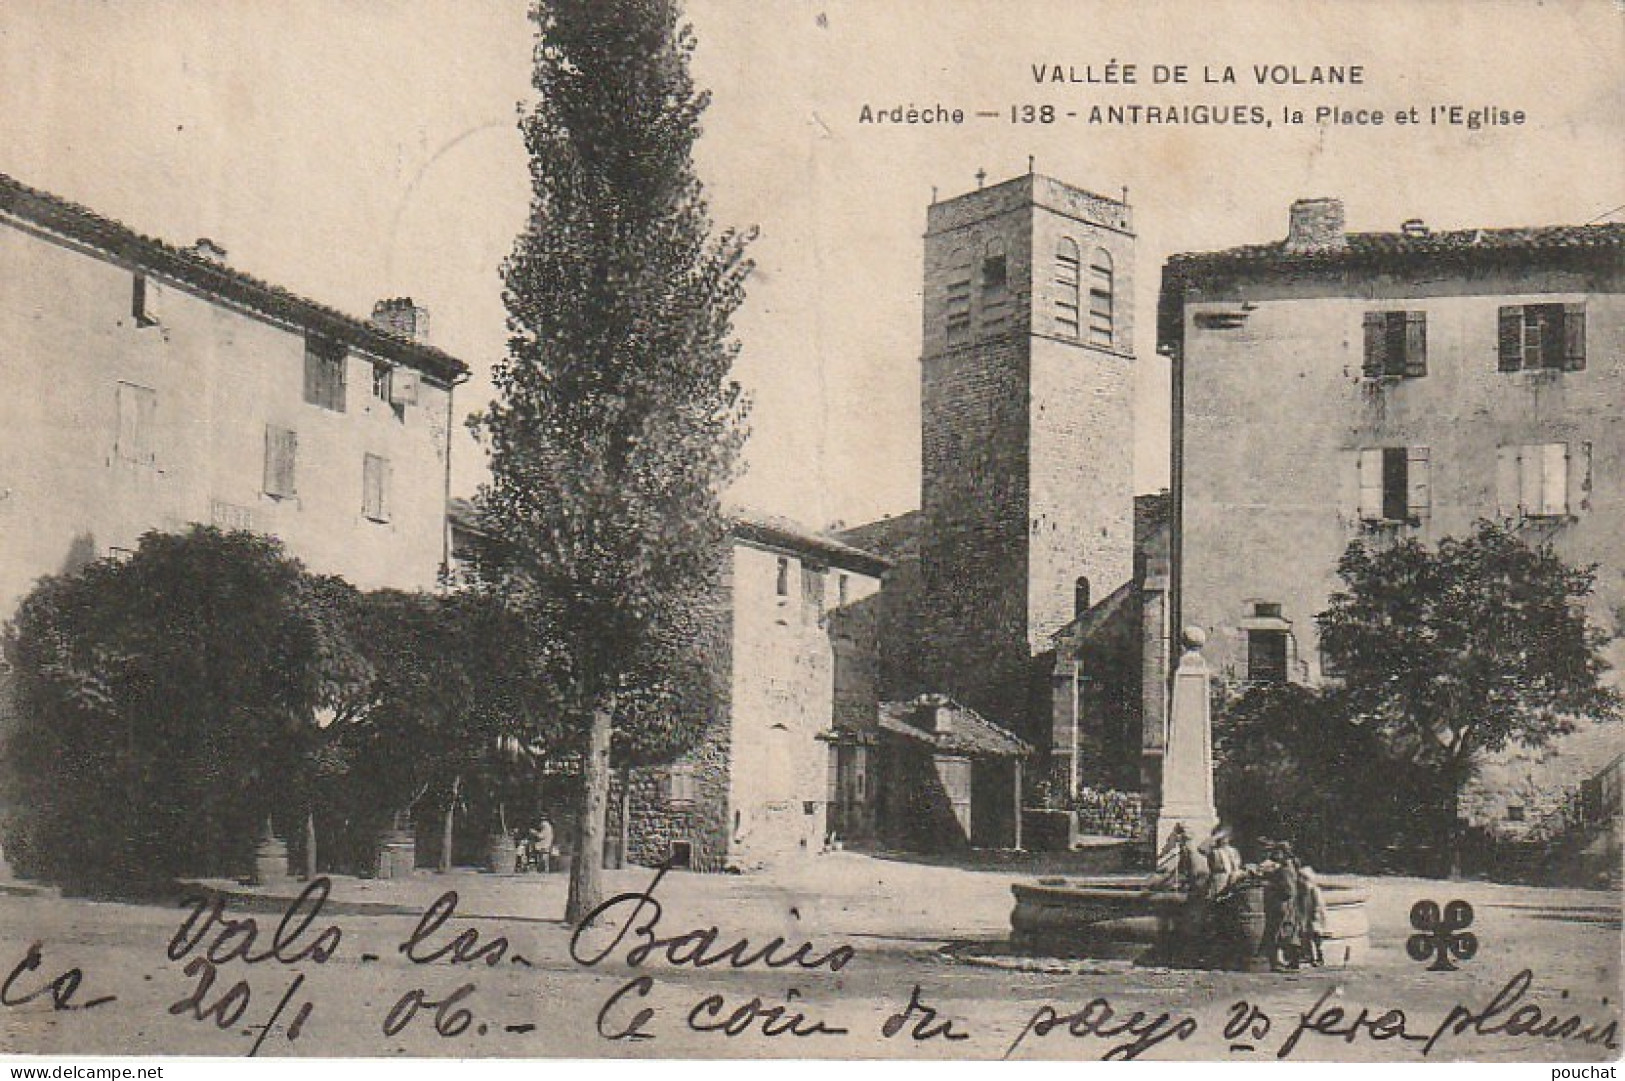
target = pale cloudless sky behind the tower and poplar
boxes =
[0,0,1625,527]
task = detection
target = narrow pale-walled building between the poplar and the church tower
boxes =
[611,514,886,871]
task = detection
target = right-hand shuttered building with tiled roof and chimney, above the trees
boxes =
[1159,200,1625,824]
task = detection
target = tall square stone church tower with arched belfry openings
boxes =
[920,172,1134,749]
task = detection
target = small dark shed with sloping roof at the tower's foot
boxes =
[879,694,1032,852]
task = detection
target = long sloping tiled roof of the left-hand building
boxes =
[0,172,468,382]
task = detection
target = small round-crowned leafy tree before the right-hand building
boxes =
[1318,522,1620,865]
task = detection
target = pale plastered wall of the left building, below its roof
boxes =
[0,214,450,618]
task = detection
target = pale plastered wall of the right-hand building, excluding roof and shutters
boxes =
[1181,267,1625,679]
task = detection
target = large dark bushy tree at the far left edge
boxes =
[5,527,354,884]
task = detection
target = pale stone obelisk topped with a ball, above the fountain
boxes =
[1157,627,1219,852]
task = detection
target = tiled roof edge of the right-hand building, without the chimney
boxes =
[1168,223,1625,270]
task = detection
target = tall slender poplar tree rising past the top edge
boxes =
[478,0,749,920]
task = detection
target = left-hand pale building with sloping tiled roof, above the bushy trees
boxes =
[0,176,468,618]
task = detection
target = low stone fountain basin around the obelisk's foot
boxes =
[1011,876,1372,967]
